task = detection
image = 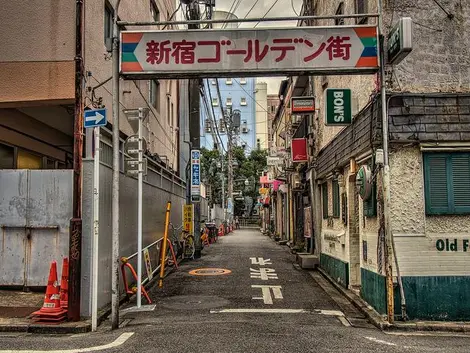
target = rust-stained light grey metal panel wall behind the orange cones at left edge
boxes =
[0,170,73,287]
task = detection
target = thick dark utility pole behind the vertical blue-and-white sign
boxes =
[186,1,202,258]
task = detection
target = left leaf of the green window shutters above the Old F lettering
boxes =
[424,153,451,215]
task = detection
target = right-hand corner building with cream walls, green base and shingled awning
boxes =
[273,0,470,320]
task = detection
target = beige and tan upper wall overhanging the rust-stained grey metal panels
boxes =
[0,0,75,105]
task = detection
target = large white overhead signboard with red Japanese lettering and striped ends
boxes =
[120,26,379,78]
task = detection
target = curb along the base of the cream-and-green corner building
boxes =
[317,267,470,333]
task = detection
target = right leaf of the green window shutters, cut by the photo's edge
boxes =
[451,153,470,214]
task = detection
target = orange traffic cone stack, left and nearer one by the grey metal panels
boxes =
[31,261,67,322]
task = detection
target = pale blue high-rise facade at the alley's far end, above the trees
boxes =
[200,77,257,153]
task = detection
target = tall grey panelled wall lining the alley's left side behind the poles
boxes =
[82,160,185,316]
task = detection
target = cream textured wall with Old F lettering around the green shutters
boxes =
[390,147,470,276]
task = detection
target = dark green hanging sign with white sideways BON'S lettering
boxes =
[325,88,352,125]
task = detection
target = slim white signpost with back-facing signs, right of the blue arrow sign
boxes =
[123,108,149,308]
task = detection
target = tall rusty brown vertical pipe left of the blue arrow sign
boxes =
[68,0,84,321]
